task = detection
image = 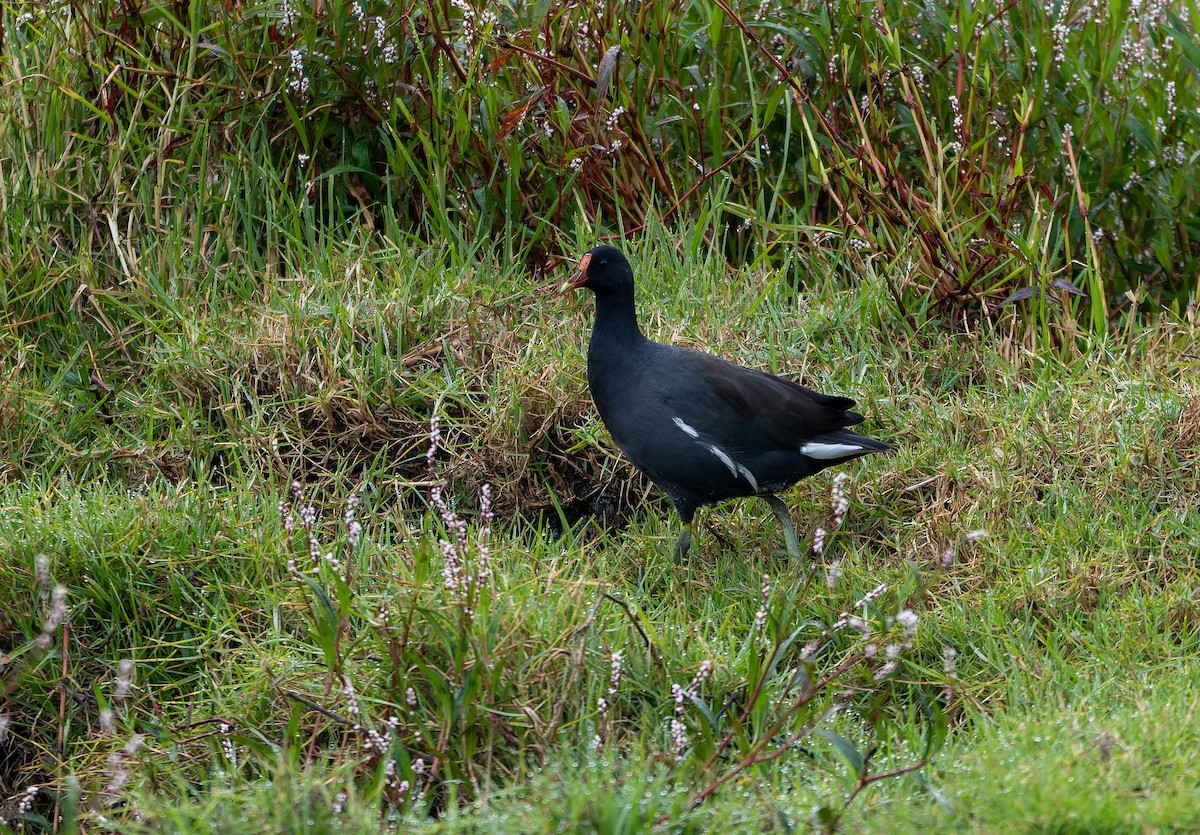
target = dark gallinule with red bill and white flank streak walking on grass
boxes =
[563,246,892,558]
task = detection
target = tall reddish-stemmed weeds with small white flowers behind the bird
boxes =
[5,0,1200,331]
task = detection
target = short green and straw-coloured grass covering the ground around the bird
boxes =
[0,226,1200,831]
